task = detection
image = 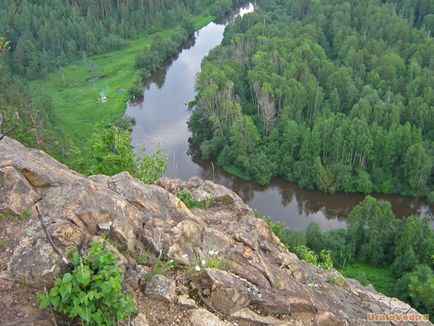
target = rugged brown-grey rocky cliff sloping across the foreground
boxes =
[0,138,430,325]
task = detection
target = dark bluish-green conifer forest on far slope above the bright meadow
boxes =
[0,0,244,78]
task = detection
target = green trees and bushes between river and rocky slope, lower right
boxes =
[267,196,434,320]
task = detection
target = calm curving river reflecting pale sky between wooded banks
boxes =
[125,3,434,230]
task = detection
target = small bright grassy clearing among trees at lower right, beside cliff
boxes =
[340,262,396,297]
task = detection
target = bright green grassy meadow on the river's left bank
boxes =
[29,13,214,145]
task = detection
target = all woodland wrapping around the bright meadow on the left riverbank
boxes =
[0,0,244,163]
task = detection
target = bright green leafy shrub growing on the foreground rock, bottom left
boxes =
[38,242,137,325]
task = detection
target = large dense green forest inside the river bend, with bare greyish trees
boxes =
[189,0,434,200]
